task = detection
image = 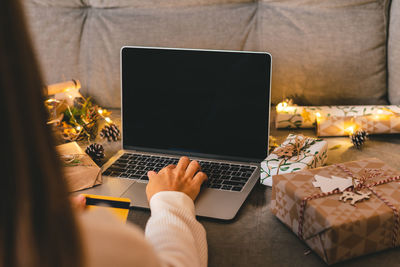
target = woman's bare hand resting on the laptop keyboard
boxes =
[146,157,207,202]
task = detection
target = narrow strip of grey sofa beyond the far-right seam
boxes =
[388,1,400,105]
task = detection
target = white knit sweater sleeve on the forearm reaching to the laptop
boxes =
[145,191,208,267]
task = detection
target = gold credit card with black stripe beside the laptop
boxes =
[82,194,131,222]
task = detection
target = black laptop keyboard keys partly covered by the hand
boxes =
[103,153,256,192]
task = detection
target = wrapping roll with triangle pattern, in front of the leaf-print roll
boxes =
[317,114,400,136]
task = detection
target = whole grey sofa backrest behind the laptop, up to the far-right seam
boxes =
[21,0,389,107]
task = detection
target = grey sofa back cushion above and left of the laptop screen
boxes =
[24,0,257,107]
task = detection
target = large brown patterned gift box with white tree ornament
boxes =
[271,158,400,264]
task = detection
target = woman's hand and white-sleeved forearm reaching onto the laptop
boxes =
[145,157,207,267]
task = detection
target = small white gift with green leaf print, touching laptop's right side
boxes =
[260,134,328,186]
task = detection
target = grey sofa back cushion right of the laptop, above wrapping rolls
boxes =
[258,0,388,105]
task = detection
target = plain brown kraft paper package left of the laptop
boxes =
[56,142,102,192]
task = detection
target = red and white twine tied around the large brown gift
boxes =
[297,164,400,247]
